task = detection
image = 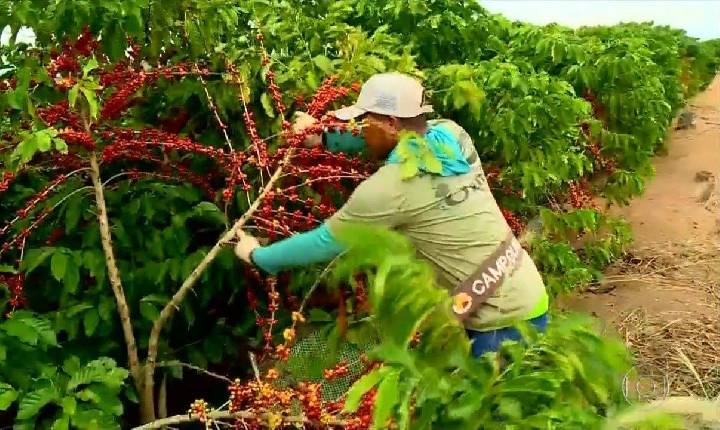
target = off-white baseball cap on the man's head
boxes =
[333,72,433,121]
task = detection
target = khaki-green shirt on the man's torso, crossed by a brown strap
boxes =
[326,120,548,331]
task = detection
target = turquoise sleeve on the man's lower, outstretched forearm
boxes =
[252,224,345,275]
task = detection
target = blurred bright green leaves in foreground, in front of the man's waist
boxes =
[334,223,672,429]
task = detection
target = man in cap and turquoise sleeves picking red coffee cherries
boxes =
[235,73,548,356]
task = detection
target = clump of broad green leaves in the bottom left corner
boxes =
[0,311,128,429]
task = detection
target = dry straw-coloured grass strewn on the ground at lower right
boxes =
[606,242,720,400]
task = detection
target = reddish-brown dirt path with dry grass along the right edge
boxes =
[562,76,720,397]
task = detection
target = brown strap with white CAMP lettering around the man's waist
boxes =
[452,233,525,321]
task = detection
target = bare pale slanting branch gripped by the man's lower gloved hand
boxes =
[142,148,294,420]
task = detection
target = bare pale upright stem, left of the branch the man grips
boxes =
[90,152,142,390]
